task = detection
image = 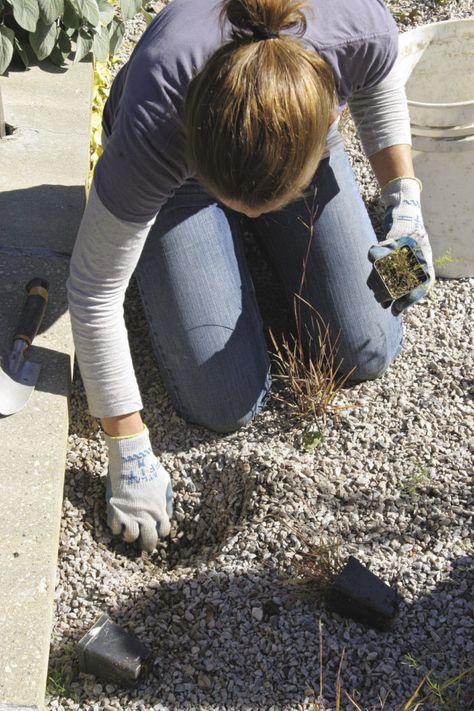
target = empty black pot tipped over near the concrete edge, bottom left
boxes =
[78,615,151,687]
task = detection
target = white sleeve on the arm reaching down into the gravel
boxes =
[67,181,154,417]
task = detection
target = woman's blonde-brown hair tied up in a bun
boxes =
[185,0,336,207]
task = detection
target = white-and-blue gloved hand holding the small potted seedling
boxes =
[369,178,435,314]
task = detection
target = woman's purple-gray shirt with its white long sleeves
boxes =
[68,0,411,417]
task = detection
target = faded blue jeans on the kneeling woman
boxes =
[136,129,402,432]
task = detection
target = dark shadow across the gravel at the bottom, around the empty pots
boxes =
[50,558,474,711]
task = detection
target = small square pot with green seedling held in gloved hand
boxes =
[374,245,428,299]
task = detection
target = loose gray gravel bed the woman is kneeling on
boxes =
[49,0,474,711]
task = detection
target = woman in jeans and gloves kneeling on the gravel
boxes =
[68,0,433,550]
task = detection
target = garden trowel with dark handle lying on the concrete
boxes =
[0,277,49,415]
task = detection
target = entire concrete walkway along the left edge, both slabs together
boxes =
[0,57,92,711]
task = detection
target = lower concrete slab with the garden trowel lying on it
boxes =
[0,255,72,705]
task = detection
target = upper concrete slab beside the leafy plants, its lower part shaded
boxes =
[0,63,91,252]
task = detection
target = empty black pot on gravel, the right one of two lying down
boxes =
[326,556,402,630]
